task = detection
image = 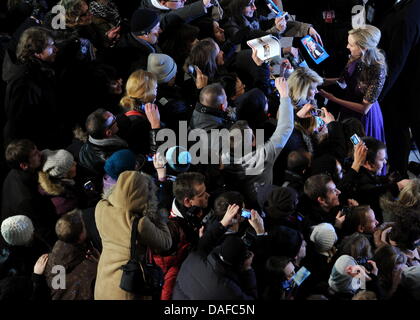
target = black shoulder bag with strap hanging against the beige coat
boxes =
[120,215,163,297]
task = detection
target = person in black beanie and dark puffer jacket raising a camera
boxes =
[172,205,257,300]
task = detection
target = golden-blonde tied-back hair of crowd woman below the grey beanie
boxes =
[120,70,157,110]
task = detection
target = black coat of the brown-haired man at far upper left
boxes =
[3,51,64,149]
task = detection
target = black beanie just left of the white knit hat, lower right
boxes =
[268,226,303,259]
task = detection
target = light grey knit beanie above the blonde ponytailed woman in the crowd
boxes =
[147,53,177,83]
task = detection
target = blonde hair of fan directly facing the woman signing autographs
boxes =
[287,67,324,107]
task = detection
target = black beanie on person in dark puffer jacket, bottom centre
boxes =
[219,235,248,267]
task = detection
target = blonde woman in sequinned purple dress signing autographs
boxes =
[320,25,387,142]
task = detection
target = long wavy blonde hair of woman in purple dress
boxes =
[349,24,387,70]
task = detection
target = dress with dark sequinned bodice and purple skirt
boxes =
[340,59,386,175]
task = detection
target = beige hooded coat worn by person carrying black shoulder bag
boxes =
[95,171,172,300]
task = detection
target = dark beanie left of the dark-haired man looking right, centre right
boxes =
[257,185,297,219]
